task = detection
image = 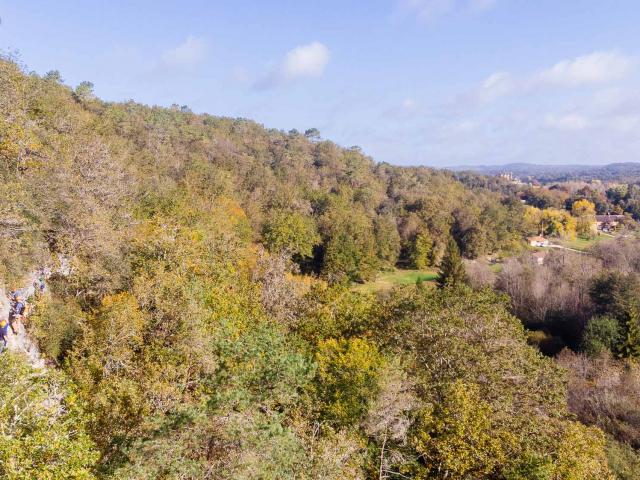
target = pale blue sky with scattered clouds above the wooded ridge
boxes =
[0,0,640,167]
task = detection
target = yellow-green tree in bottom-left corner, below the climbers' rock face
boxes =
[0,352,98,480]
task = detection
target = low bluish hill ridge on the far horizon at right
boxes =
[449,162,640,182]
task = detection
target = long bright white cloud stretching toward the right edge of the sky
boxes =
[474,52,635,103]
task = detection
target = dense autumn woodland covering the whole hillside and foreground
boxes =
[0,59,640,480]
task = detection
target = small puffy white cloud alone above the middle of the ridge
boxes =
[256,42,331,88]
